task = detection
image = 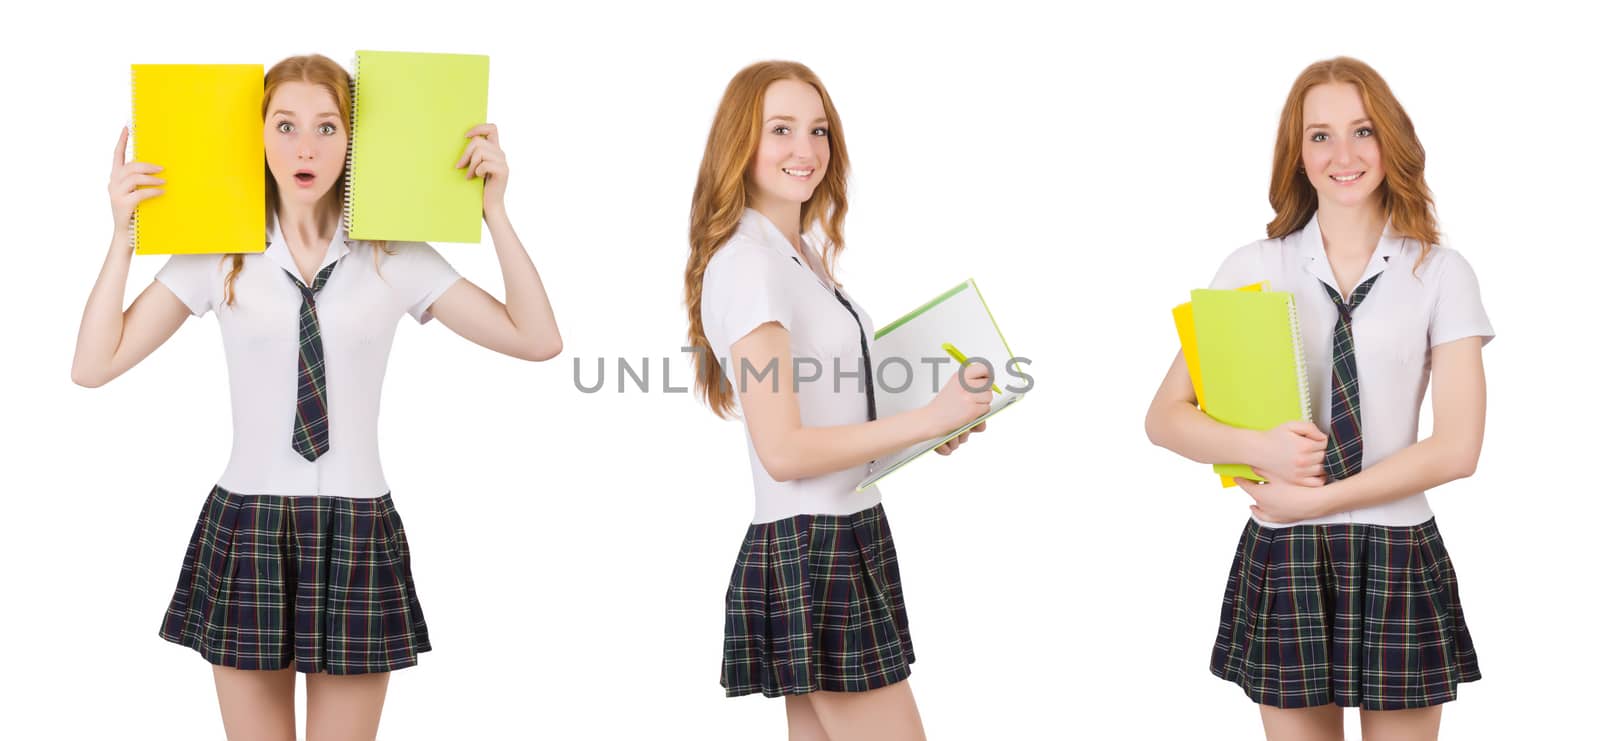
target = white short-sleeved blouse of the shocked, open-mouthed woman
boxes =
[155,226,459,498]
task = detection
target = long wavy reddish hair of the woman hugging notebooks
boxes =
[1267,56,1438,266]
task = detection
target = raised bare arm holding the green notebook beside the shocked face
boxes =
[430,123,562,360]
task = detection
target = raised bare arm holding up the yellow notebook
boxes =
[72,128,189,387]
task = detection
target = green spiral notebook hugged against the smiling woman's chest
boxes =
[1190,288,1310,480]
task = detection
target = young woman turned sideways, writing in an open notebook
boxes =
[685,62,990,741]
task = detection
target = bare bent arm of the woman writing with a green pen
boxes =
[728,322,990,482]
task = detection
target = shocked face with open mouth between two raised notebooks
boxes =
[262,82,350,206]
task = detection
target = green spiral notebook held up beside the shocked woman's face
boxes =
[344,51,490,242]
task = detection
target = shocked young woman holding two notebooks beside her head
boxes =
[72,56,562,739]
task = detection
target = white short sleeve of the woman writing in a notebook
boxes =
[701,238,794,352]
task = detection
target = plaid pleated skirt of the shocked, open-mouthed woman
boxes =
[162,487,430,674]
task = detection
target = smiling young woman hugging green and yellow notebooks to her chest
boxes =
[1146,58,1494,739]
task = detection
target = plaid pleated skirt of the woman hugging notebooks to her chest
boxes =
[1211,519,1482,711]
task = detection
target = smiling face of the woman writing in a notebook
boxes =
[749,80,829,214]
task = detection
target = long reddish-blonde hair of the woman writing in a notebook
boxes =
[683,61,850,418]
